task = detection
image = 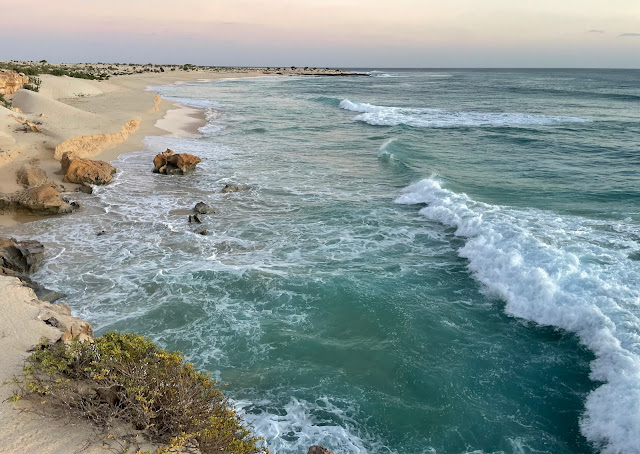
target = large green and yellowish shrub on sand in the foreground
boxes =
[22,332,269,454]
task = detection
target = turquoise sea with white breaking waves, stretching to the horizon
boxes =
[8,70,640,454]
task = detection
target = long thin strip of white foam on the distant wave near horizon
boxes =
[340,99,589,128]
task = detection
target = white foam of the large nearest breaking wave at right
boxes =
[396,177,640,454]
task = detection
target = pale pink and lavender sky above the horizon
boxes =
[0,0,640,68]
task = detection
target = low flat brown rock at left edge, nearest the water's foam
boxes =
[0,184,78,215]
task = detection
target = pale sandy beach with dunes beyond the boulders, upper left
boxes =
[0,71,264,226]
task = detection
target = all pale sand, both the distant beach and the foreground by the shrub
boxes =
[0,68,258,454]
